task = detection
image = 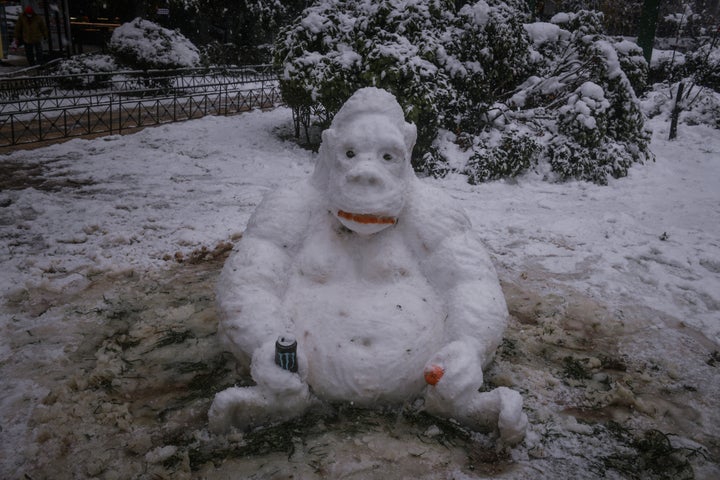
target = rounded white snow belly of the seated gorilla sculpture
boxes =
[287,277,445,405]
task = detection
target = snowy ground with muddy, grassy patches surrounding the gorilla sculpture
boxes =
[0,103,720,480]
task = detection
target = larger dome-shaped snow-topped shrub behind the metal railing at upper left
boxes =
[109,18,200,70]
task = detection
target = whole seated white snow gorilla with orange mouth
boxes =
[209,88,527,443]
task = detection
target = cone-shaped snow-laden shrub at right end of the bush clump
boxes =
[514,12,652,183]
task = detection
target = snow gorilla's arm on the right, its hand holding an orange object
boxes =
[409,184,508,402]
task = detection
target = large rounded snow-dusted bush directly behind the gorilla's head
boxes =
[275,0,528,163]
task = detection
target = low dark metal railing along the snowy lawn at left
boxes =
[0,66,282,147]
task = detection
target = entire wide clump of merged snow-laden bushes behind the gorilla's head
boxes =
[275,0,652,183]
